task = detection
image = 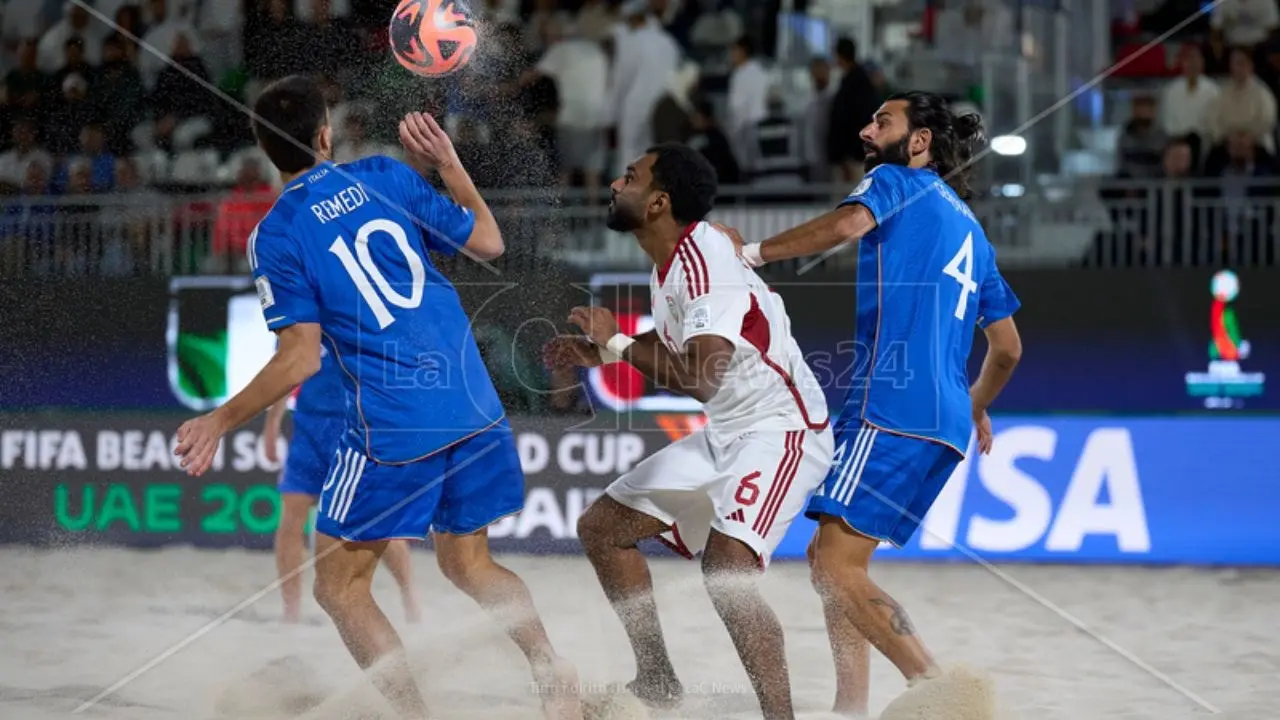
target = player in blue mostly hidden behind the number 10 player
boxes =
[262,346,422,623]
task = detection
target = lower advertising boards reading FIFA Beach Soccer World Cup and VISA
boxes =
[0,413,1280,566]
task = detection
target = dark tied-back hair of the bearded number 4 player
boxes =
[886,91,986,200]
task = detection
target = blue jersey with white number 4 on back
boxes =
[841,164,1020,455]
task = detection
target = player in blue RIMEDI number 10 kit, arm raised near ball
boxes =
[175,76,582,720]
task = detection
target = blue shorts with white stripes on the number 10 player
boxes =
[316,420,525,542]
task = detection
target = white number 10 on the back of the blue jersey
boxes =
[329,218,426,329]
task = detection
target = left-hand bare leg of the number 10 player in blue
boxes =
[315,534,426,720]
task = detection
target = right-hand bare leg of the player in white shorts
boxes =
[703,530,795,720]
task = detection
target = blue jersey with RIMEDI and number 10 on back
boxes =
[248,156,503,464]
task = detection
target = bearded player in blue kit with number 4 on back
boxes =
[742,92,1021,717]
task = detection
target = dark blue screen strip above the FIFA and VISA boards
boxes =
[0,269,1280,415]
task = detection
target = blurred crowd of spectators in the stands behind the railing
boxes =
[0,0,1280,274]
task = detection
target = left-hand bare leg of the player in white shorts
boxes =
[577,496,684,707]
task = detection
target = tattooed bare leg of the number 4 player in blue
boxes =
[813,515,938,680]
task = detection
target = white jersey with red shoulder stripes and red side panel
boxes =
[649,223,828,437]
